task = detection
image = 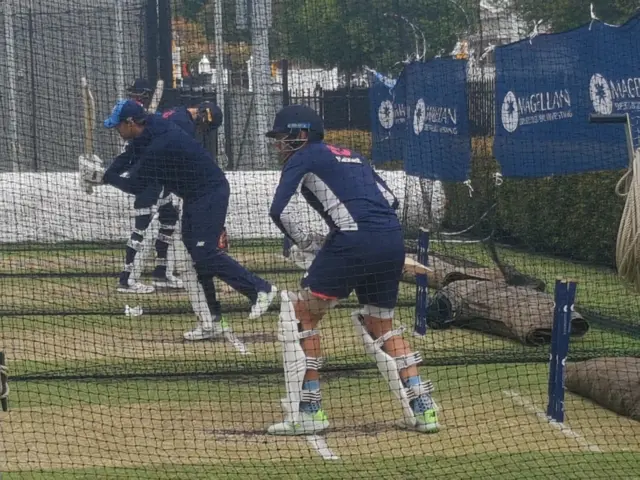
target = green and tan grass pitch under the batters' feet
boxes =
[0,240,640,480]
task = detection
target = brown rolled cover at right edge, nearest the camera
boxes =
[565,357,640,421]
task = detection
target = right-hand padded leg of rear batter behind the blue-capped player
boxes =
[152,195,183,288]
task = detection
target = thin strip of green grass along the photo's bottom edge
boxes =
[3,452,640,480]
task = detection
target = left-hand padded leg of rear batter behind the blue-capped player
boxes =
[118,192,157,294]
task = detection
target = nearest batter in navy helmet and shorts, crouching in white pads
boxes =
[267,105,439,435]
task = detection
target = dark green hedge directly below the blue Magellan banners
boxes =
[445,141,624,266]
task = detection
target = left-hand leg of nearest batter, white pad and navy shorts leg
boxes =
[267,242,353,435]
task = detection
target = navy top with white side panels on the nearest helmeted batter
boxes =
[269,142,401,245]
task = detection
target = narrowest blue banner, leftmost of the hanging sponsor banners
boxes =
[369,68,407,164]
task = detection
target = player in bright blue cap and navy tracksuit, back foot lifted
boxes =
[80,100,276,341]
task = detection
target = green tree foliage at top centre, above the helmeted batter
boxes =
[274,0,473,72]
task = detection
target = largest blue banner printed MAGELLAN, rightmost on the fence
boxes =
[494,17,640,177]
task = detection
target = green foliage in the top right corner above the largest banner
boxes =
[513,0,640,32]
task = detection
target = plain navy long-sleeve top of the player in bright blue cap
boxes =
[104,115,228,202]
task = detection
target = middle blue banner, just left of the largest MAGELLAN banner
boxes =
[403,58,471,182]
